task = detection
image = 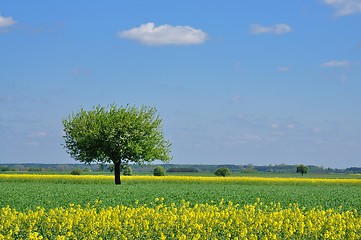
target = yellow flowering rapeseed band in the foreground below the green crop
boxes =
[0,199,361,239]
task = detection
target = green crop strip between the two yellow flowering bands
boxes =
[0,172,361,211]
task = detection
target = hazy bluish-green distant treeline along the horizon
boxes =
[0,163,361,173]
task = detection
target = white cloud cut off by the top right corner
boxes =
[323,0,361,16]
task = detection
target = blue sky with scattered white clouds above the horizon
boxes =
[0,0,361,168]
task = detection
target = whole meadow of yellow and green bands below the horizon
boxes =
[0,174,361,239]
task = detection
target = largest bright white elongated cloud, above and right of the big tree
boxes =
[118,22,207,45]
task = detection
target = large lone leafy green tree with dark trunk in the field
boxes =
[63,104,171,184]
